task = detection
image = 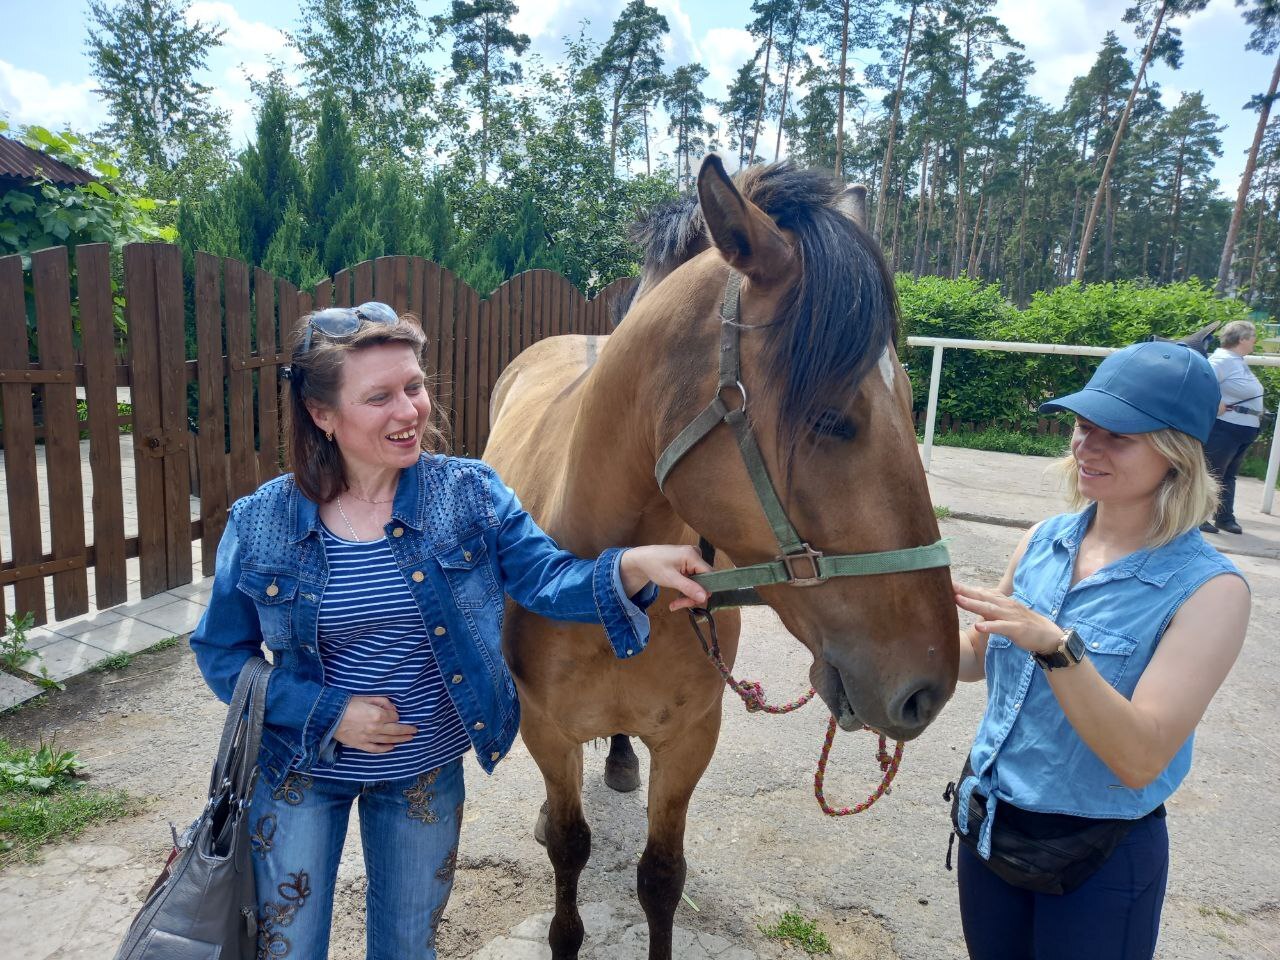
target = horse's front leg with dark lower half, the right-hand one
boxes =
[636,703,721,960]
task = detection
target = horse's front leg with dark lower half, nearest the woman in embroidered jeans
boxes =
[521,722,591,960]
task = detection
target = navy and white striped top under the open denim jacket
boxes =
[311,527,471,782]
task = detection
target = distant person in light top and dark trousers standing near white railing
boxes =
[1201,320,1262,534]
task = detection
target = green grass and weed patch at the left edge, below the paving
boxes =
[0,740,138,868]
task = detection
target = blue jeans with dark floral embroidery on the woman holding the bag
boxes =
[250,759,466,960]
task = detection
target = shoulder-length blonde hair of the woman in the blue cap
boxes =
[1055,429,1219,547]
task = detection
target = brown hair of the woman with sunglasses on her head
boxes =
[285,314,444,503]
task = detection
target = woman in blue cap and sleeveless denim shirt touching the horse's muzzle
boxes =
[952,343,1249,960]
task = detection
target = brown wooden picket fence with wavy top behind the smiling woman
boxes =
[0,243,634,623]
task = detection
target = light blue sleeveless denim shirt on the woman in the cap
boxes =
[957,504,1240,858]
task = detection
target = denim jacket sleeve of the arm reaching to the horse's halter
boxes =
[486,468,657,658]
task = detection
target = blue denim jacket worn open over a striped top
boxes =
[191,454,657,790]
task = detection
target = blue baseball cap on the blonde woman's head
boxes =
[1041,340,1222,443]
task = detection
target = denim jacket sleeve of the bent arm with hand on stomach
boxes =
[191,516,351,758]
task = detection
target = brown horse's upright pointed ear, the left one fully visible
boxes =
[698,154,794,287]
